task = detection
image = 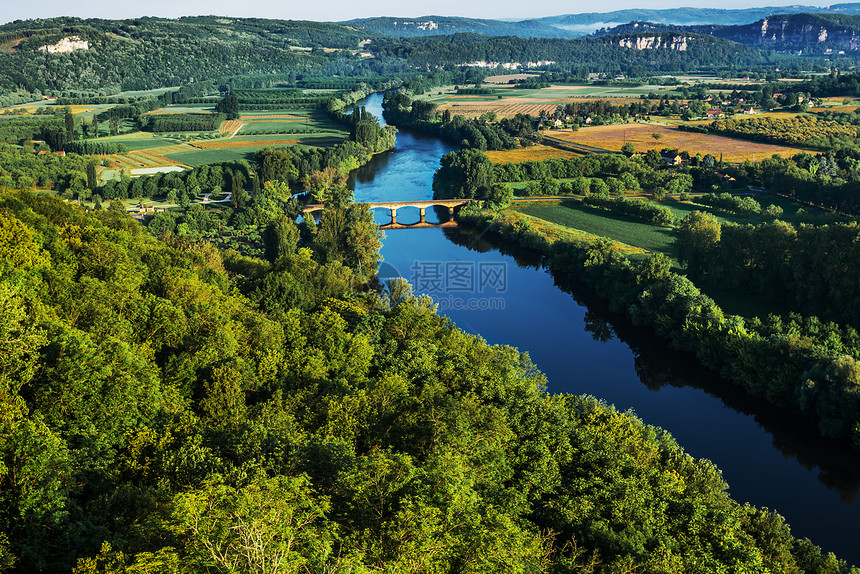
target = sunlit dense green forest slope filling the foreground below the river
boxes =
[0,188,853,573]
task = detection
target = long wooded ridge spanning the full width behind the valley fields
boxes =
[0,16,854,105]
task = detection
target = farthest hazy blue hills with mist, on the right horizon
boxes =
[539,3,860,35]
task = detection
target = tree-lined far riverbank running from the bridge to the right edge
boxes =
[460,208,860,449]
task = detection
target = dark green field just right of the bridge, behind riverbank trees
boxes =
[517,202,674,255]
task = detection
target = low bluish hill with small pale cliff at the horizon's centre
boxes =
[340,16,582,38]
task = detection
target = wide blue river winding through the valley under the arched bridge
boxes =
[350,94,860,564]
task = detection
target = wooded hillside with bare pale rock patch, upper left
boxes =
[0,17,369,93]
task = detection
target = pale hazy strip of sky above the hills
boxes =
[0,0,822,23]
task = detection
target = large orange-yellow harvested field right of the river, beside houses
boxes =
[545,124,804,162]
